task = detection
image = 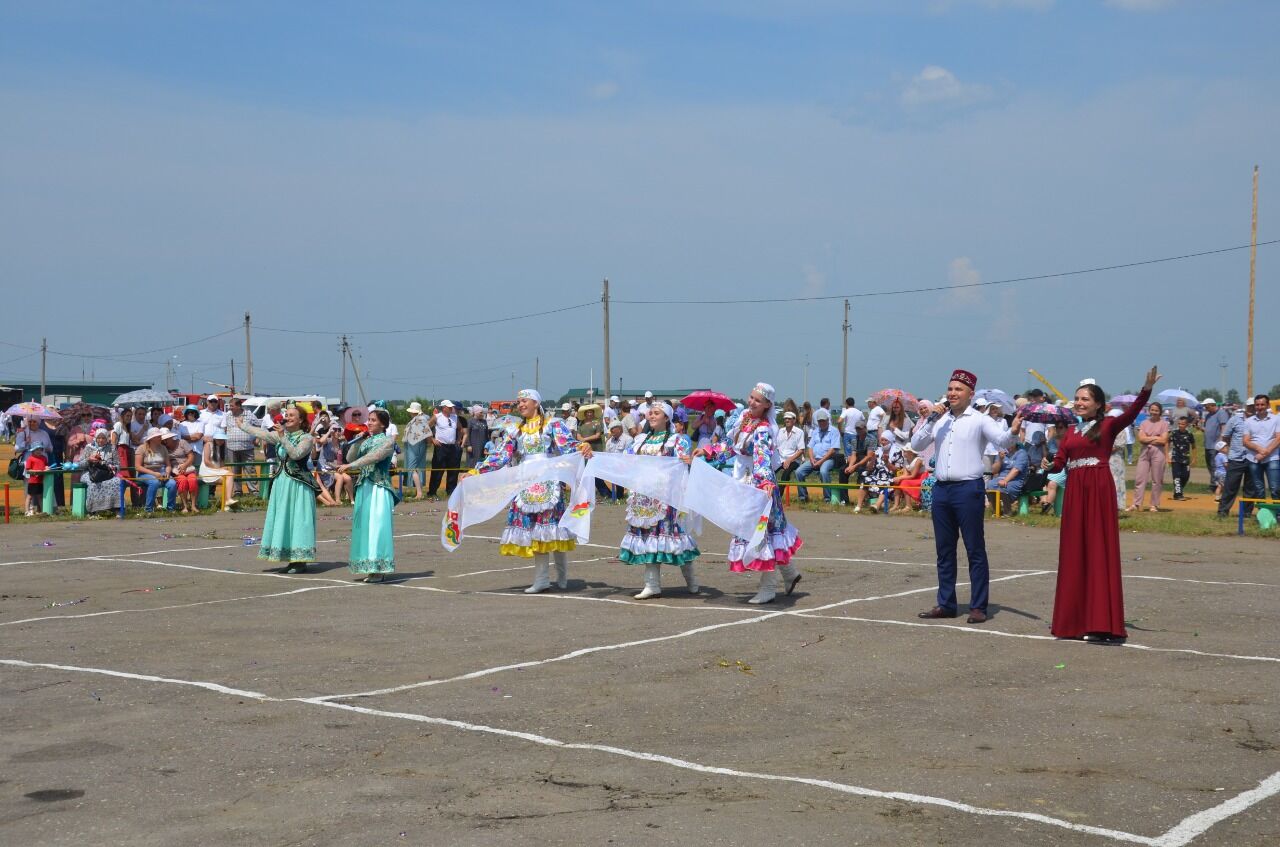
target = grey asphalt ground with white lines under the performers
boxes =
[0,504,1280,847]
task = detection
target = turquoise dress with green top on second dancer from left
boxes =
[348,432,399,573]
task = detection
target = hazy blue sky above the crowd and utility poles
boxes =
[0,0,1280,399]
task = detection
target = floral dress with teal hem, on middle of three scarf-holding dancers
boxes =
[618,431,701,567]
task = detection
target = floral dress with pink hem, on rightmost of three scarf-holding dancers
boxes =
[728,415,804,572]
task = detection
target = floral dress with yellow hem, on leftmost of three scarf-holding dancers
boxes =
[476,415,577,559]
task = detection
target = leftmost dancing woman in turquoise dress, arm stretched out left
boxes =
[232,406,319,573]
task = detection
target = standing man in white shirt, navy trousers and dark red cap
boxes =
[911,370,1023,623]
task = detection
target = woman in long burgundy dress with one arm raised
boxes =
[1052,367,1160,644]
